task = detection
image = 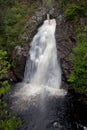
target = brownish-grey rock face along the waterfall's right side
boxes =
[56,13,75,87]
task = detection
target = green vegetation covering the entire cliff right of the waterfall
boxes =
[60,0,87,104]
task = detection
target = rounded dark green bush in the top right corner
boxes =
[64,4,85,21]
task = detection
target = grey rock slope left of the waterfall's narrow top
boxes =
[22,7,47,41]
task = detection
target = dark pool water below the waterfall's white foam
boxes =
[10,95,77,130]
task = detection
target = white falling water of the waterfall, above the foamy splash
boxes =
[24,19,61,88]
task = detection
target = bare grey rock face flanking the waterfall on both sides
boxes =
[13,3,75,85]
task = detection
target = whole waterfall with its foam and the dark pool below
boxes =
[11,19,86,130]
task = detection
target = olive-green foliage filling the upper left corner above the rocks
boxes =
[0,0,36,52]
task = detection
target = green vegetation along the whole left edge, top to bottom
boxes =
[0,0,36,130]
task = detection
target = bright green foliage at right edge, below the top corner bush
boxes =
[68,26,87,96]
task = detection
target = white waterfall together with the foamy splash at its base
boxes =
[12,19,66,109]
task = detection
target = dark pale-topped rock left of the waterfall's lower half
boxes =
[12,45,29,81]
